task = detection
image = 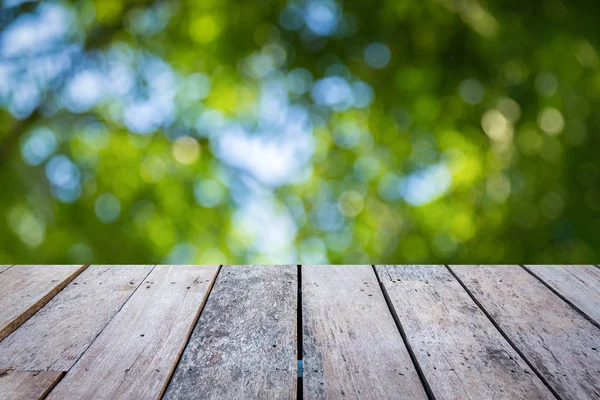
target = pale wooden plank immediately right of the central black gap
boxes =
[302,265,427,399]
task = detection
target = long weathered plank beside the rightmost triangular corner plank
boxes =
[451,265,600,400]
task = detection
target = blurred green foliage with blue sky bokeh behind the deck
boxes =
[0,0,600,264]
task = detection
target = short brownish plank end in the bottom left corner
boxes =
[0,370,64,400]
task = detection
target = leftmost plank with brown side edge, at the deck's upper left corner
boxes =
[0,265,87,340]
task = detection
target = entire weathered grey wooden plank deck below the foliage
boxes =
[0,265,600,400]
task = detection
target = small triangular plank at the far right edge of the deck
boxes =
[526,265,600,324]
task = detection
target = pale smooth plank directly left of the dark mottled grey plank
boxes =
[48,265,218,399]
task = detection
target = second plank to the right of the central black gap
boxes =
[376,265,554,400]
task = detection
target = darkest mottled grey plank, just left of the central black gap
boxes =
[163,265,298,399]
